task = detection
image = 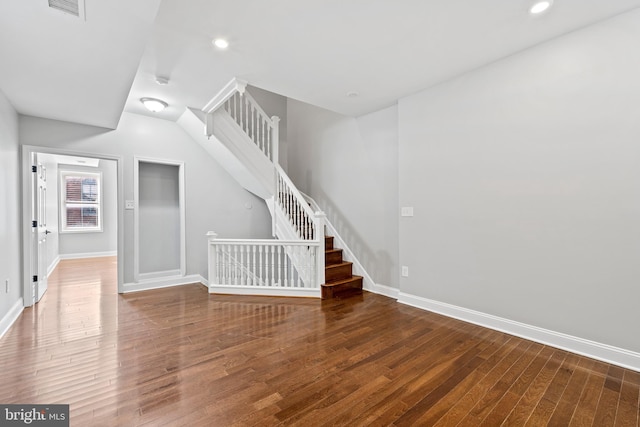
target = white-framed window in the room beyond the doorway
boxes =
[60,171,102,232]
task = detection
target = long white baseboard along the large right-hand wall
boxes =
[398,292,640,371]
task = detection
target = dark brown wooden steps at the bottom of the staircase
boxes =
[322,236,363,299]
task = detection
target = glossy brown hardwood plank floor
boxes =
[0,258,640,427]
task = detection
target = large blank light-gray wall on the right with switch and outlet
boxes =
[399,11,640,352]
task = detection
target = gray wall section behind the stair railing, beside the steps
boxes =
[287,100,398,287]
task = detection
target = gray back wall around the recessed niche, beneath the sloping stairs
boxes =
[20,113,271,283]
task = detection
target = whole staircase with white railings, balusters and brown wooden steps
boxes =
[178,79,373,298]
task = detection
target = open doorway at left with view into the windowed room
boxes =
[22,146,123,307]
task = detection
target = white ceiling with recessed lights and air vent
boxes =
[0,0,640,128]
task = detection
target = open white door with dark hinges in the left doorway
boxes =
[31,155,50,303]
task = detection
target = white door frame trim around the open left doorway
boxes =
[21,145,124,307]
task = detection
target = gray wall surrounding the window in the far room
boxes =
[57,159,118,258]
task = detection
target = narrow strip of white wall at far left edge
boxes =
[0,91,22,335]
